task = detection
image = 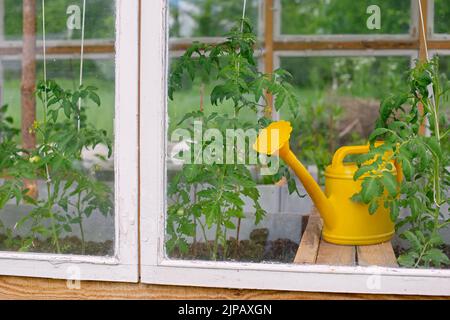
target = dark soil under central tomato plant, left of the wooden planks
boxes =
[170,229,298,263]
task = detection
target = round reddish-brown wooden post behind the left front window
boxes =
[21,0,36,149]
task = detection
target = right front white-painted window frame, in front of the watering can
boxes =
[140,0,450,295]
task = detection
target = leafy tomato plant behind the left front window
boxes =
[0,80,113,254]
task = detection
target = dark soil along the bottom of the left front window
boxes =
[0,235,114,256]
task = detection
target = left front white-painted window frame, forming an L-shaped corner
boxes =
[0,0,139,282]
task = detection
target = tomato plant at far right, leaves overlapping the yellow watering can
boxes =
[354,58,450,267]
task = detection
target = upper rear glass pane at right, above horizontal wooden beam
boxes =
[281,0,411,35]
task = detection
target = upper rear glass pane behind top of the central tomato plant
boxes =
[169,0,261,38]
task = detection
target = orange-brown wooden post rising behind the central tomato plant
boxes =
[264,0,274,118]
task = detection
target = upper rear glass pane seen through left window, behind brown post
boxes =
[4,0,115,40]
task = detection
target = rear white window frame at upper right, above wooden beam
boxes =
[274,0,419,42]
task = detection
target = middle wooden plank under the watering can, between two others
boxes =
[316,239,356,266]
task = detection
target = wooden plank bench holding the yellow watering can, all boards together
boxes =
[294,209,398,267]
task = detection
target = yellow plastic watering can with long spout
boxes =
[253,121,402,245]
